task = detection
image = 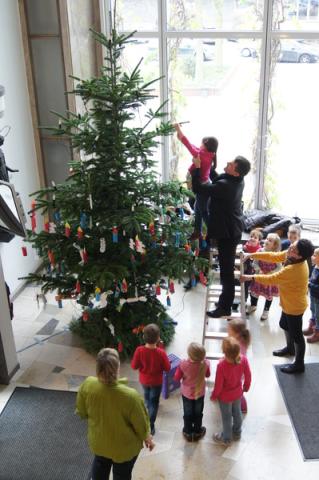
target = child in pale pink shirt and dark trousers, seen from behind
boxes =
[174,342,210,442]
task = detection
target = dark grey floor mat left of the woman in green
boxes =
[0,387,92,480]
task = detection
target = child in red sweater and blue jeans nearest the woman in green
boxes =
[131,323,171,435]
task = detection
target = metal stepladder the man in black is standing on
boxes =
[202,245,246,360]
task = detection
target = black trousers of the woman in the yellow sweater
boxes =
[279,312,306,364]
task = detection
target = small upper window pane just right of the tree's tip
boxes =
[112,0,158,32]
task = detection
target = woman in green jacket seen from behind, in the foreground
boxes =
[76,348,154,480]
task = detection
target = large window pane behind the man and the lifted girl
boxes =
[169,39,260,204]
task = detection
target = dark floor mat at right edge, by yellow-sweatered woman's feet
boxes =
[274,363,319,460]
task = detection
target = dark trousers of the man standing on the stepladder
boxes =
[217,237,241,310]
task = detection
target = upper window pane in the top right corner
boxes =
[273,0,319,31]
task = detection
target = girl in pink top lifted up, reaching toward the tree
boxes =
[174,123,218,238]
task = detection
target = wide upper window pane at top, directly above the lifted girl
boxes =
[167,0,264,31]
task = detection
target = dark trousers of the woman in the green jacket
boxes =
[92,455,137,480]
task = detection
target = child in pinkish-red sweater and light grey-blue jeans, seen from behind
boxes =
[210,337,251,446]
